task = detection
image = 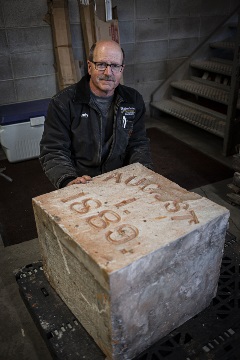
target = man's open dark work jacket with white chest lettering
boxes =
[39,75,152,188]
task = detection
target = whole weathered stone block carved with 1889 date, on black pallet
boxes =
[33,164,229,360]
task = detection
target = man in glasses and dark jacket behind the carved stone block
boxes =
[40,41,152,188]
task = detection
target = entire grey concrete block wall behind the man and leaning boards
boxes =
[0,0,239,109]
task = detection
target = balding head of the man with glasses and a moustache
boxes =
[88,40,124,96]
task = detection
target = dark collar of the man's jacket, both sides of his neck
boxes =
[73,74,131,104]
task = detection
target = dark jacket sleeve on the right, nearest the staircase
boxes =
[125,92,153,170]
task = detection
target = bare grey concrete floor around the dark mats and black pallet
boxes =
[0,118,240,360]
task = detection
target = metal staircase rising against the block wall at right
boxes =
[150,10,240,156]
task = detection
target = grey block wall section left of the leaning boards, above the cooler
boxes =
[0,0,57,105]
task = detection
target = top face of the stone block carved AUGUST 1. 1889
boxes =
[33,163,229,275]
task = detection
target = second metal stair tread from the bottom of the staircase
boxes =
[171,80,240,109]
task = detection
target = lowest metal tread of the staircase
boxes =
[152,99,225,138]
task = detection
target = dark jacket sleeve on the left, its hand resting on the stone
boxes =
[39,96,77,188]
